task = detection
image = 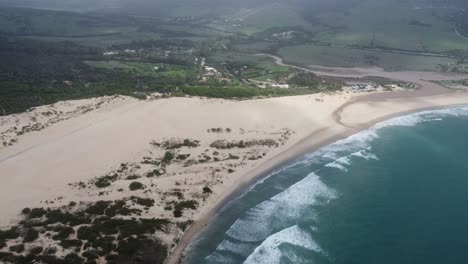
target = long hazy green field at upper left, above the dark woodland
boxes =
[0,8,218,48]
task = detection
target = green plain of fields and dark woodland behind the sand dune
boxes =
[0,0,468,113]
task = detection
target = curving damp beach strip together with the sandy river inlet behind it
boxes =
[166,54,468,264]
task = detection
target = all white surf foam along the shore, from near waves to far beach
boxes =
[209,107,468,263]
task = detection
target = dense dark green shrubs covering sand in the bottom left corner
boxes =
[0,200,172,264]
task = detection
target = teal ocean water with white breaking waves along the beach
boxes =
[188,107,468,264]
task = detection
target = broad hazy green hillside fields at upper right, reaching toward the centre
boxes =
[203,0,468,53]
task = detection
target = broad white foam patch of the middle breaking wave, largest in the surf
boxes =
[206,173,336,263]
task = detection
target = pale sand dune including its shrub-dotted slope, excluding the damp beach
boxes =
[0,93,358,262]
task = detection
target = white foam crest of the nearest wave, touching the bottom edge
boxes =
[244,225,323,264]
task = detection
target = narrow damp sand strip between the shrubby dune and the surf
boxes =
[166,93,468,264]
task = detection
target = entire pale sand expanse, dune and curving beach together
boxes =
[0,62,468,264]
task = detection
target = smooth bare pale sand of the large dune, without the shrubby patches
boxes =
[0,95,349,225]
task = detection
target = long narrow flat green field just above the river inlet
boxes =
[278,45,455,71]
